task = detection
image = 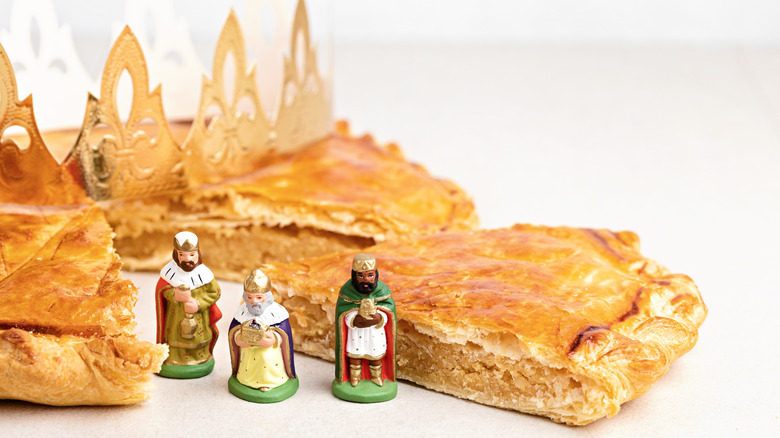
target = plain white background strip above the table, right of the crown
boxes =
[335,0,780,45]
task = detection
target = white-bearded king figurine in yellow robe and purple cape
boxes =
[228,269,298,403]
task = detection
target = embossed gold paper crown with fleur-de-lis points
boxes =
[0,0,332,201]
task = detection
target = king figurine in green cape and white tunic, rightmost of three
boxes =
[332,254,398,403]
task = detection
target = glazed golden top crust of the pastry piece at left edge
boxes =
[0,204,135,336]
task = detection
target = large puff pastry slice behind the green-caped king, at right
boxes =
[262,225,707,425]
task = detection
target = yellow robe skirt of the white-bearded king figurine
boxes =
[236,332,288,389]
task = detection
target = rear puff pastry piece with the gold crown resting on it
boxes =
[106,122,477,281]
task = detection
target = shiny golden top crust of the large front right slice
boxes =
[263,225,706,396]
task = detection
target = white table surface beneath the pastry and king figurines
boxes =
[0,46,780,437]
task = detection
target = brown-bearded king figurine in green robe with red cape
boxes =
[155,231,222,379]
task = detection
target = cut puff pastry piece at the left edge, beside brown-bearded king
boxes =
[0,204,168,405]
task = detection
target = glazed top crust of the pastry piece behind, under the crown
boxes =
[170,124,477,241]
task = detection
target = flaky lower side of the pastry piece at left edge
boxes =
[0,329,168,406]
